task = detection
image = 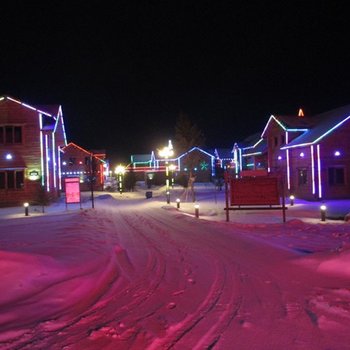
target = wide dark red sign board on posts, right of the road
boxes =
[230,176,280,205]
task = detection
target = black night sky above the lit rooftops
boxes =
[0,0,350,161]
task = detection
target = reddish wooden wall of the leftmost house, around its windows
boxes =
[0,98,65,206]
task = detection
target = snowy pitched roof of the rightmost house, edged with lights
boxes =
[281,105,350,149]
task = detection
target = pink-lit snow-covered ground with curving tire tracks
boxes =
[0,184,350,350]
